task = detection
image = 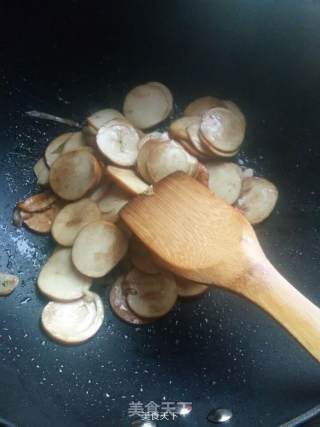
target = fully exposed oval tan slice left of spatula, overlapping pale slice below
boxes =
[72,221,128,277]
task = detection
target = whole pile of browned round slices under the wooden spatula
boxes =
[7,82,278,344]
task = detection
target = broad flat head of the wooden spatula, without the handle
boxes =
[121,173,261,287]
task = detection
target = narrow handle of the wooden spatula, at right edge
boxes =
[240,260,320,362]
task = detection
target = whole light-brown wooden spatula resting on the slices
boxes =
[121,173,320,361]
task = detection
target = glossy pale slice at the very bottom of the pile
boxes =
[41,292,104,344]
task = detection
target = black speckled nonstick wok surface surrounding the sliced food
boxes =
[0,0,320,427]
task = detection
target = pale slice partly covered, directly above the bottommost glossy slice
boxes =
[38,248,92,301]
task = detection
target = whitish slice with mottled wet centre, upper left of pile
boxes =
[97,120,140,166]
